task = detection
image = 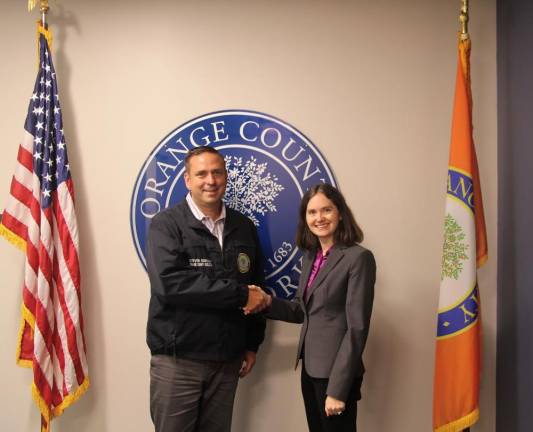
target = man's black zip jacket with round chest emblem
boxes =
[147,200,265,361]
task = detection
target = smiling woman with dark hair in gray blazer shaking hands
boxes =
[266,184,376,432]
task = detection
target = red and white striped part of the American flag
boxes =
[2,132,89,422]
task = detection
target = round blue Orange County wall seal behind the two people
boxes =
[130,110,335,298]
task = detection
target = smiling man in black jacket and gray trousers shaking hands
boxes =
[147,147,266,432]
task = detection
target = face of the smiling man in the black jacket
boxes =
[184,153,227,210]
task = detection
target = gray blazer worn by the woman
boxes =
[265,245,376,401]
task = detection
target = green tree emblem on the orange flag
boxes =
[441,214,468,280]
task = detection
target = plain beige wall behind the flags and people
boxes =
[0,0,497,432]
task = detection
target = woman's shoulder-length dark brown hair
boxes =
[296,183,363,250]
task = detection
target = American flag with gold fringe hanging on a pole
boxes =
[0,26,89,430]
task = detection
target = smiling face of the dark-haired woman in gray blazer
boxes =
[305,192,339,245]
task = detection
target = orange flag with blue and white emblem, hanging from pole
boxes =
[433,39,487,432]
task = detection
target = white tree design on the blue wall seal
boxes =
[224,156,285,227]
